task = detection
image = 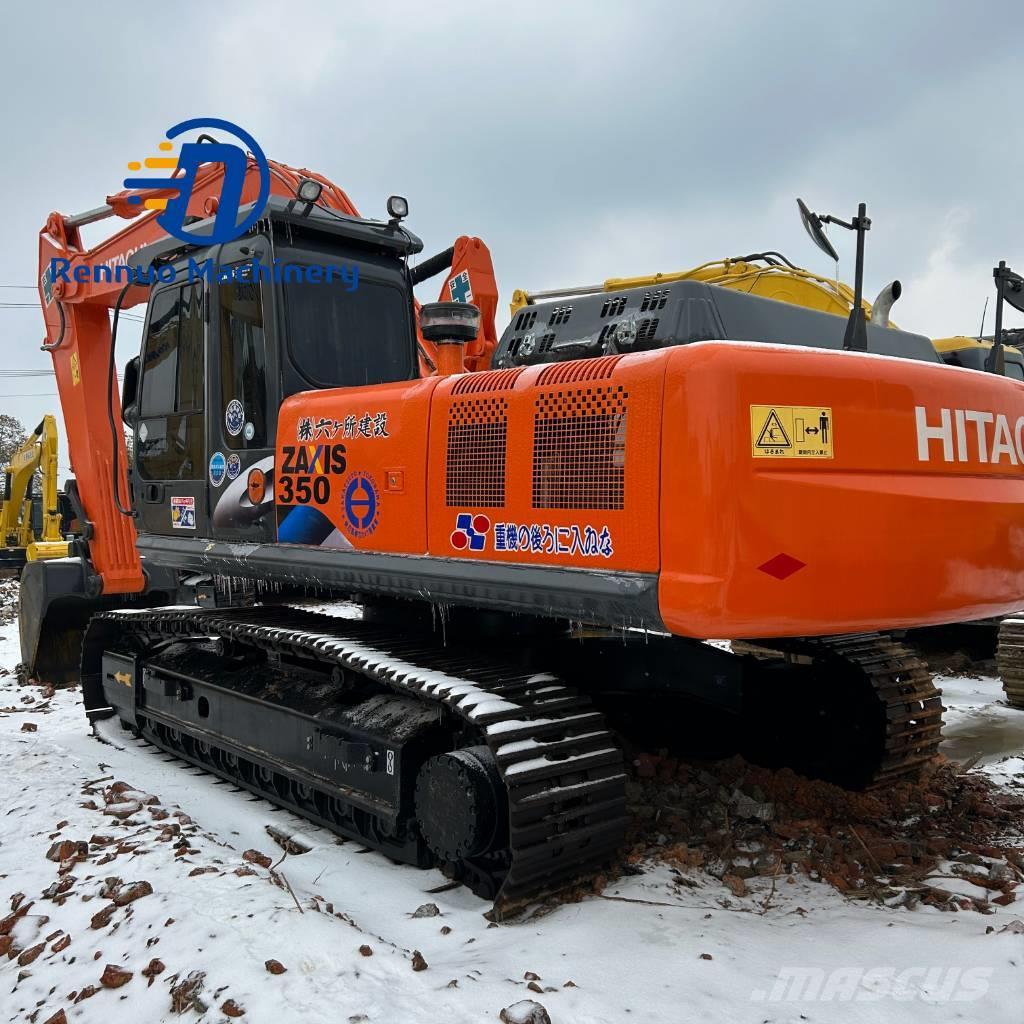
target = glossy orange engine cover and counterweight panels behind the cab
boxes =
[276,342,1024,638]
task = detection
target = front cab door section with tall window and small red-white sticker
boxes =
[135,281,209,538]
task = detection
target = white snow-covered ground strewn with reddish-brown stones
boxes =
[0,610,1024,1024]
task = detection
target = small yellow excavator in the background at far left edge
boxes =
[0,414,68,578]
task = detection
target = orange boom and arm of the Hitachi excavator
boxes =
[39,157,498,596]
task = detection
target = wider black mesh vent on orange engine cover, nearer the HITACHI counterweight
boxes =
[534,385,629,509]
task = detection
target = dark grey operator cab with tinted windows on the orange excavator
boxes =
[122,197,422,543]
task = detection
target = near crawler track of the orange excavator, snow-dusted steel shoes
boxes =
[83,607,626,916]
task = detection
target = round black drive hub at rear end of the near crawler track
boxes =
[416,746,508,865]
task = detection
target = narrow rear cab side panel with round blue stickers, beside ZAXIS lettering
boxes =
[207,258,280,543]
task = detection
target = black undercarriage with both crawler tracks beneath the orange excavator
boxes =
[82,605,942,918]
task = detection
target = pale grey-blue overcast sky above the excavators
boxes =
[0,0,1024,473]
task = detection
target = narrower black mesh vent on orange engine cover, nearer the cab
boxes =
[444,395,516,508]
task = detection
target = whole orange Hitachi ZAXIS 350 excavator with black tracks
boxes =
[22,140,1024,912]
